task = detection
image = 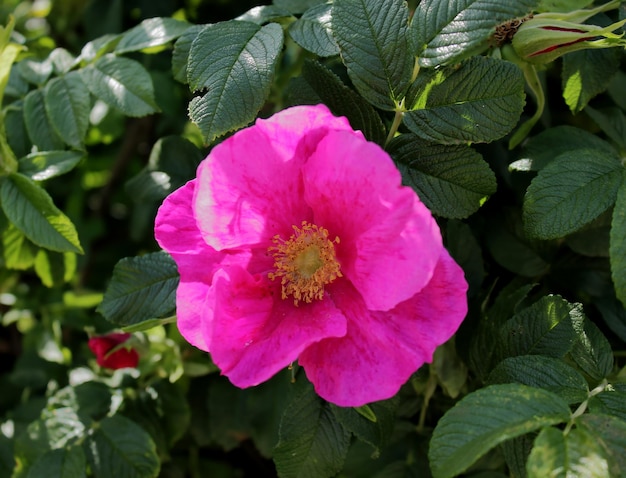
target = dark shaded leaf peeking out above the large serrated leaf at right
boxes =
[509,125,618,171]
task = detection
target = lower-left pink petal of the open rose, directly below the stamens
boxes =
[211,266,346,388]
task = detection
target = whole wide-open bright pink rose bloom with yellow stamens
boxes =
[155,105,467,406]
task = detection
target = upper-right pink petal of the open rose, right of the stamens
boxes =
[303,131,442,310]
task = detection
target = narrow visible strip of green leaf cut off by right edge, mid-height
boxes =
[609,172,626,306]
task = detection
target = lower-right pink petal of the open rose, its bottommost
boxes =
[299,250,467,407]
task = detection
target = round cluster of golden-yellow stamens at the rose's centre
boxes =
[268,221,342,305]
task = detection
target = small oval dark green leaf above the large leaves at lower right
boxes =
[570,319,613,380]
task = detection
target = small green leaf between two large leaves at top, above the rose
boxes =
[289,3,339,57]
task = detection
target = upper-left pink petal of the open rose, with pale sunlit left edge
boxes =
[195,106,349,250]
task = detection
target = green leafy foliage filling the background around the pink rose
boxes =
[0,0,626,478]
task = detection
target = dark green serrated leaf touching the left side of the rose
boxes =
[97,252,179,326]
